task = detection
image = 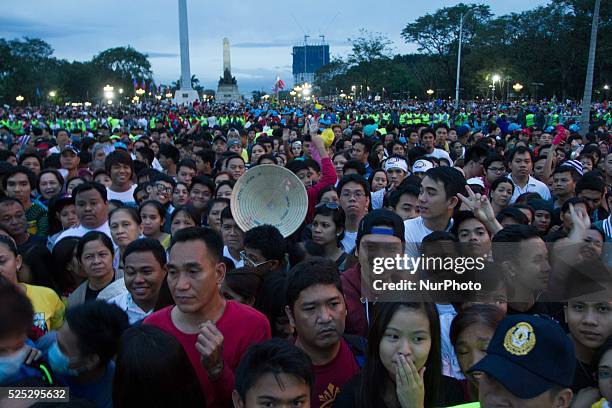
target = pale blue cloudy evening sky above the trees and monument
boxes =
[0,0,547,93]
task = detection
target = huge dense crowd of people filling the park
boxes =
[0,101,612,408]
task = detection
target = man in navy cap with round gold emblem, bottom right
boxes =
[470,315,576,408]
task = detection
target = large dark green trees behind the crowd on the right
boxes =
[315,0,612,100]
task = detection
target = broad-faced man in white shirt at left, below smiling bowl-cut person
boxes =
[55,182,112,247]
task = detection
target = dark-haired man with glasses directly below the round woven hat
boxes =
[241,225,287,278]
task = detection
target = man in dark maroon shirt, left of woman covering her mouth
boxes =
[285,257,359,408]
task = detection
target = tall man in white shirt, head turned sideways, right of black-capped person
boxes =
[404,167,466,257]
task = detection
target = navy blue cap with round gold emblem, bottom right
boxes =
[470,315,576,399]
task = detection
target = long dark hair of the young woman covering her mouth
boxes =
[358,302,442,408]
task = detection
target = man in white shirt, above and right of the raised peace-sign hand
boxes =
[508,146,552,204]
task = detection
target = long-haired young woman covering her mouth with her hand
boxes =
[334,302,464,408]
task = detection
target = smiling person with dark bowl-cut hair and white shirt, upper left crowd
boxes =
[104,149,136,206]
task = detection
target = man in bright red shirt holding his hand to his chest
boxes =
[145,227,271,407]
